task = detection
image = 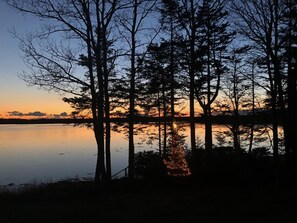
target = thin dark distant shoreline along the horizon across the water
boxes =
[0,114,280,125]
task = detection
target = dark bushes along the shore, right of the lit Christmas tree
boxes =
[191,147,292,185]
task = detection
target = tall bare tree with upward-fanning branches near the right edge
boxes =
[231,0,287,166]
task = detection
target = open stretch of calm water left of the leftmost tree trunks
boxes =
[0,125,96,185]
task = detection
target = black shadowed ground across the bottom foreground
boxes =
[0,179,297,223]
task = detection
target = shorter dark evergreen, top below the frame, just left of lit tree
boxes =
[140,40,182,155]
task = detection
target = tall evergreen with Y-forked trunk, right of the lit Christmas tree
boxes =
[195,0,234,152]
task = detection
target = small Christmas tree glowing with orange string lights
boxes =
[163,123,191,177]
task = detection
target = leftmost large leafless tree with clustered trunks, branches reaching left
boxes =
[6,0,120,183]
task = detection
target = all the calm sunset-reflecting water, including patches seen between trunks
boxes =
[0,124,276,186]
